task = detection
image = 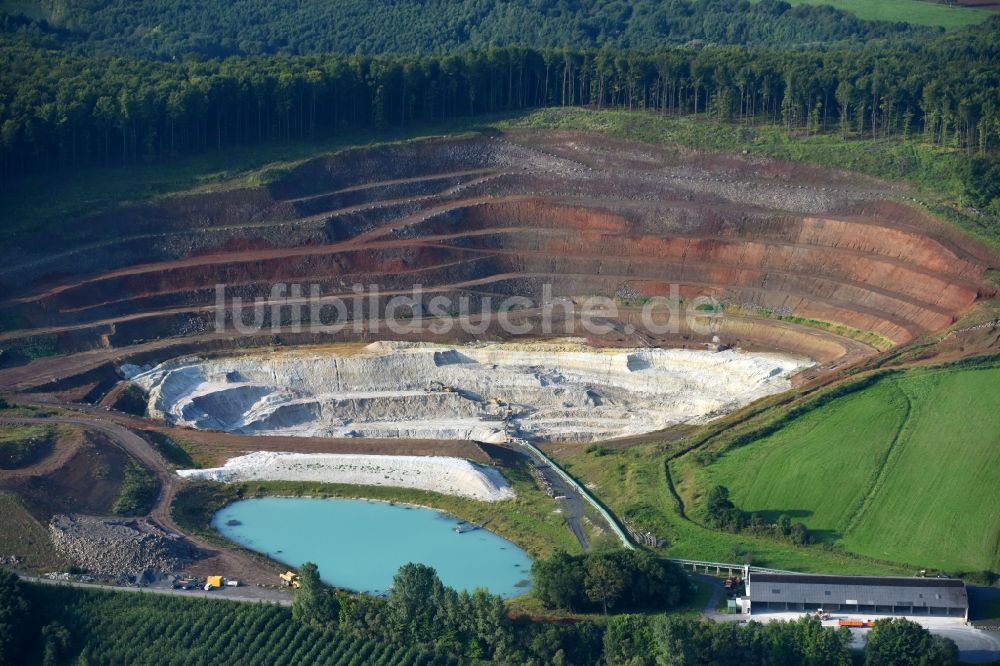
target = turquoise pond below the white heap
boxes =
[212,497,531,597]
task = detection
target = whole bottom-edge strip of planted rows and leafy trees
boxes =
[0,564,958,666]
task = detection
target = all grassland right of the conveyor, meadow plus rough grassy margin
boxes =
[556,356,1000,574]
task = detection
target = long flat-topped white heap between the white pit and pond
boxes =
[177,451,514,502]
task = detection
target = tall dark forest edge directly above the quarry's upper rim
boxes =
[0,18,1000,203]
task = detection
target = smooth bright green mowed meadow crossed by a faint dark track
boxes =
[688,368,1000,573]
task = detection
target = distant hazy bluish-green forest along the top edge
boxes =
[11,0,937,58]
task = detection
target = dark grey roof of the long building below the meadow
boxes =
[750,573,969,608]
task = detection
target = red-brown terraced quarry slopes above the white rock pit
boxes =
[0,132,1000,395]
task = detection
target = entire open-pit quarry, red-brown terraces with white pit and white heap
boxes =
[0,131,996,588]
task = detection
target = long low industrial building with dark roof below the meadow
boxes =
[740,572,969,620]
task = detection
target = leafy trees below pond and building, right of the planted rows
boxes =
[293,551,958,666]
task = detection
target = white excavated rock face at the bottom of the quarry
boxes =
[132,342,812,442]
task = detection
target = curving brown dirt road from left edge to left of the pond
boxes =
[0,416,288,585]
